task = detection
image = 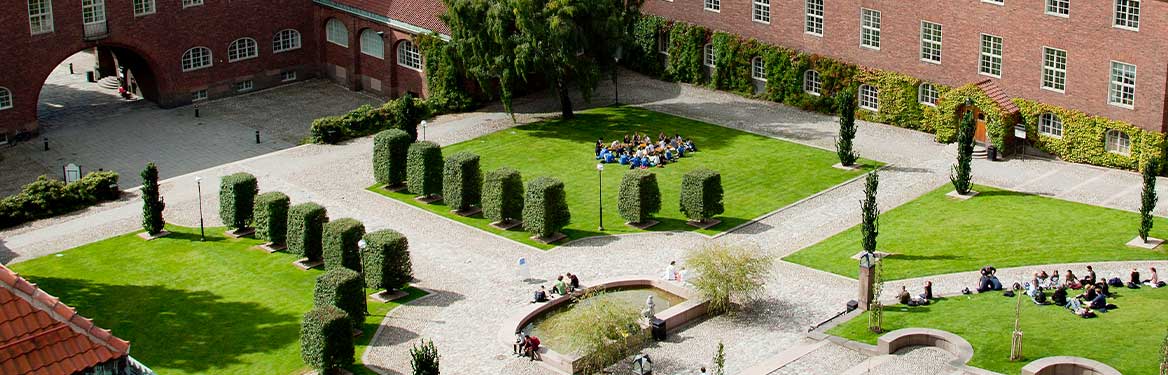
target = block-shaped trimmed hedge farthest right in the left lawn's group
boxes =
[361,229,413,291]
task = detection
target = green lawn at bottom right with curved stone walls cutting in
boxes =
[828,287,1168,375]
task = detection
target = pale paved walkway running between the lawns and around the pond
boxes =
[0,74,1164,374]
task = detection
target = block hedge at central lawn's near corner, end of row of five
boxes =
[523,176,572,237]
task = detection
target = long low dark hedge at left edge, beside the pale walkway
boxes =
[0,172,121,228]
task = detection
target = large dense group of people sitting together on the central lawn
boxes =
[596,132,697,169]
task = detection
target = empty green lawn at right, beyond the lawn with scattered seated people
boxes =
[784,185,1168,279]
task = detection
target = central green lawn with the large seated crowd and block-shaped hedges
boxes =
[369,107,876,249]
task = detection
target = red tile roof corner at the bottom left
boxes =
[0,265,130,375]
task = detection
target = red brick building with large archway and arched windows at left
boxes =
[0,0,447,141]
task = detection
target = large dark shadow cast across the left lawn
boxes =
[24,274,299,373]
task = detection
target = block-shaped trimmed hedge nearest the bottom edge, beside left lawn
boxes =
[300,305,356,373]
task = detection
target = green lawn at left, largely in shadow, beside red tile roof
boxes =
[12,227,425,375]
